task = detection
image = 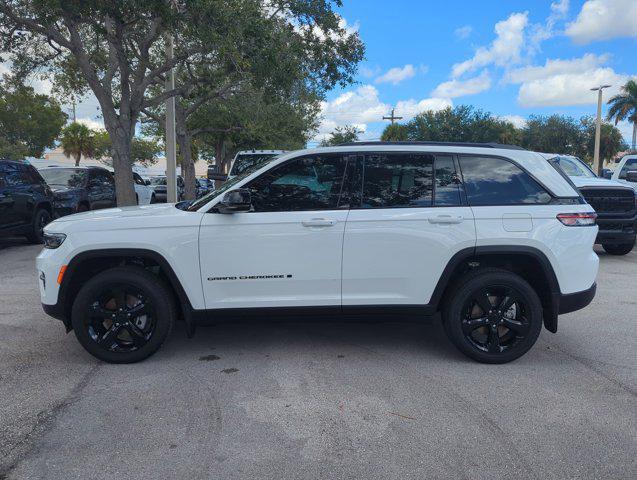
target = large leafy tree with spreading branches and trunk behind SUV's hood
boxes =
[0,0,362,205]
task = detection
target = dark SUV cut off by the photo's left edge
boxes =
[0,160,53,243]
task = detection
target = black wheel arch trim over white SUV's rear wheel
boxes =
[429,245,561,332]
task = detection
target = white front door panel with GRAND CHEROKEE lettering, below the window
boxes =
[199,210,347,308]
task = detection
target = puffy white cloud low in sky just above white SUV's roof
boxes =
[315,85,452,141]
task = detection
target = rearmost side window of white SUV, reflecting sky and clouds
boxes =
[460,155,551,206]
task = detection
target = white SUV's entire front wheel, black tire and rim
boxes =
[71,266,177,363]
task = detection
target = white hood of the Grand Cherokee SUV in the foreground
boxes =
[45,203,201,233]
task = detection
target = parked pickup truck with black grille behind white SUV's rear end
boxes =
[545,154,637,255]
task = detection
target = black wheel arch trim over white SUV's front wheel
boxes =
[58,248,193,330]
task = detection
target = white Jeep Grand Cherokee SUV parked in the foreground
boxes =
[37,142,598,363]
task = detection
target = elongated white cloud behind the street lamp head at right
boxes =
[518,68,628,107]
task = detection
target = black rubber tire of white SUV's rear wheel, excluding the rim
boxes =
[444,271,542,363]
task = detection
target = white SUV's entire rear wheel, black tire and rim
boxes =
[443,268,542,363]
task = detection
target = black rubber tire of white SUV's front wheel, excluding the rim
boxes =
[71,267,175,363]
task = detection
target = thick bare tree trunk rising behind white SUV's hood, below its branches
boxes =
[106,125,137,207]
